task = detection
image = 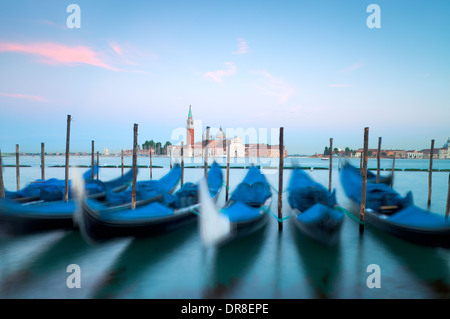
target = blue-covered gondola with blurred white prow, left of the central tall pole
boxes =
[200,165,272,247]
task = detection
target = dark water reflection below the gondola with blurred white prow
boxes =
[203,227,267,298]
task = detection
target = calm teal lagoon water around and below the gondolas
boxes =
[0,156,450,299]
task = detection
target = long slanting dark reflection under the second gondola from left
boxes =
[90,225,197,299]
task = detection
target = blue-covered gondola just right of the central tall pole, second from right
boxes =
[288,168,344,246]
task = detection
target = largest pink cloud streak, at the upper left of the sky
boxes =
[0,42,120,71]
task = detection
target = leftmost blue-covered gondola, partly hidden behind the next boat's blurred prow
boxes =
[0,169,133,236]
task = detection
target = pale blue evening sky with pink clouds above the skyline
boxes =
[0,0,450,154]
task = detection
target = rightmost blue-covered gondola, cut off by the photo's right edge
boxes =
[340,163,450,248]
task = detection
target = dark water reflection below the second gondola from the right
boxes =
[289,223,341,298]
